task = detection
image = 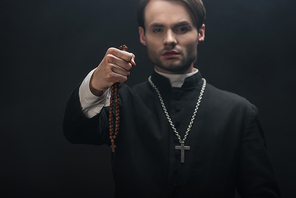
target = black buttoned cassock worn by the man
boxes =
[64,72,280,198]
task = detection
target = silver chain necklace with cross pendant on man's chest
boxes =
[148,76,206,163]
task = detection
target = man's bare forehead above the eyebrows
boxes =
[144,0,193,27]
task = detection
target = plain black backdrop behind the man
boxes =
[0,0,296,198]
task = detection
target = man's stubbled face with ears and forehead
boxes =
[139,0,205,74]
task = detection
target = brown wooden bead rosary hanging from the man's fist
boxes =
[109,45,133,153]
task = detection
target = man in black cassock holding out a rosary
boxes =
[64,0,280,198]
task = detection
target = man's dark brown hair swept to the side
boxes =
[137,0,206,30]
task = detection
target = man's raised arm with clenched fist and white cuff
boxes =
[63,48,134,144]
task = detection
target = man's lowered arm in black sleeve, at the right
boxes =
[236,106,280,198]
